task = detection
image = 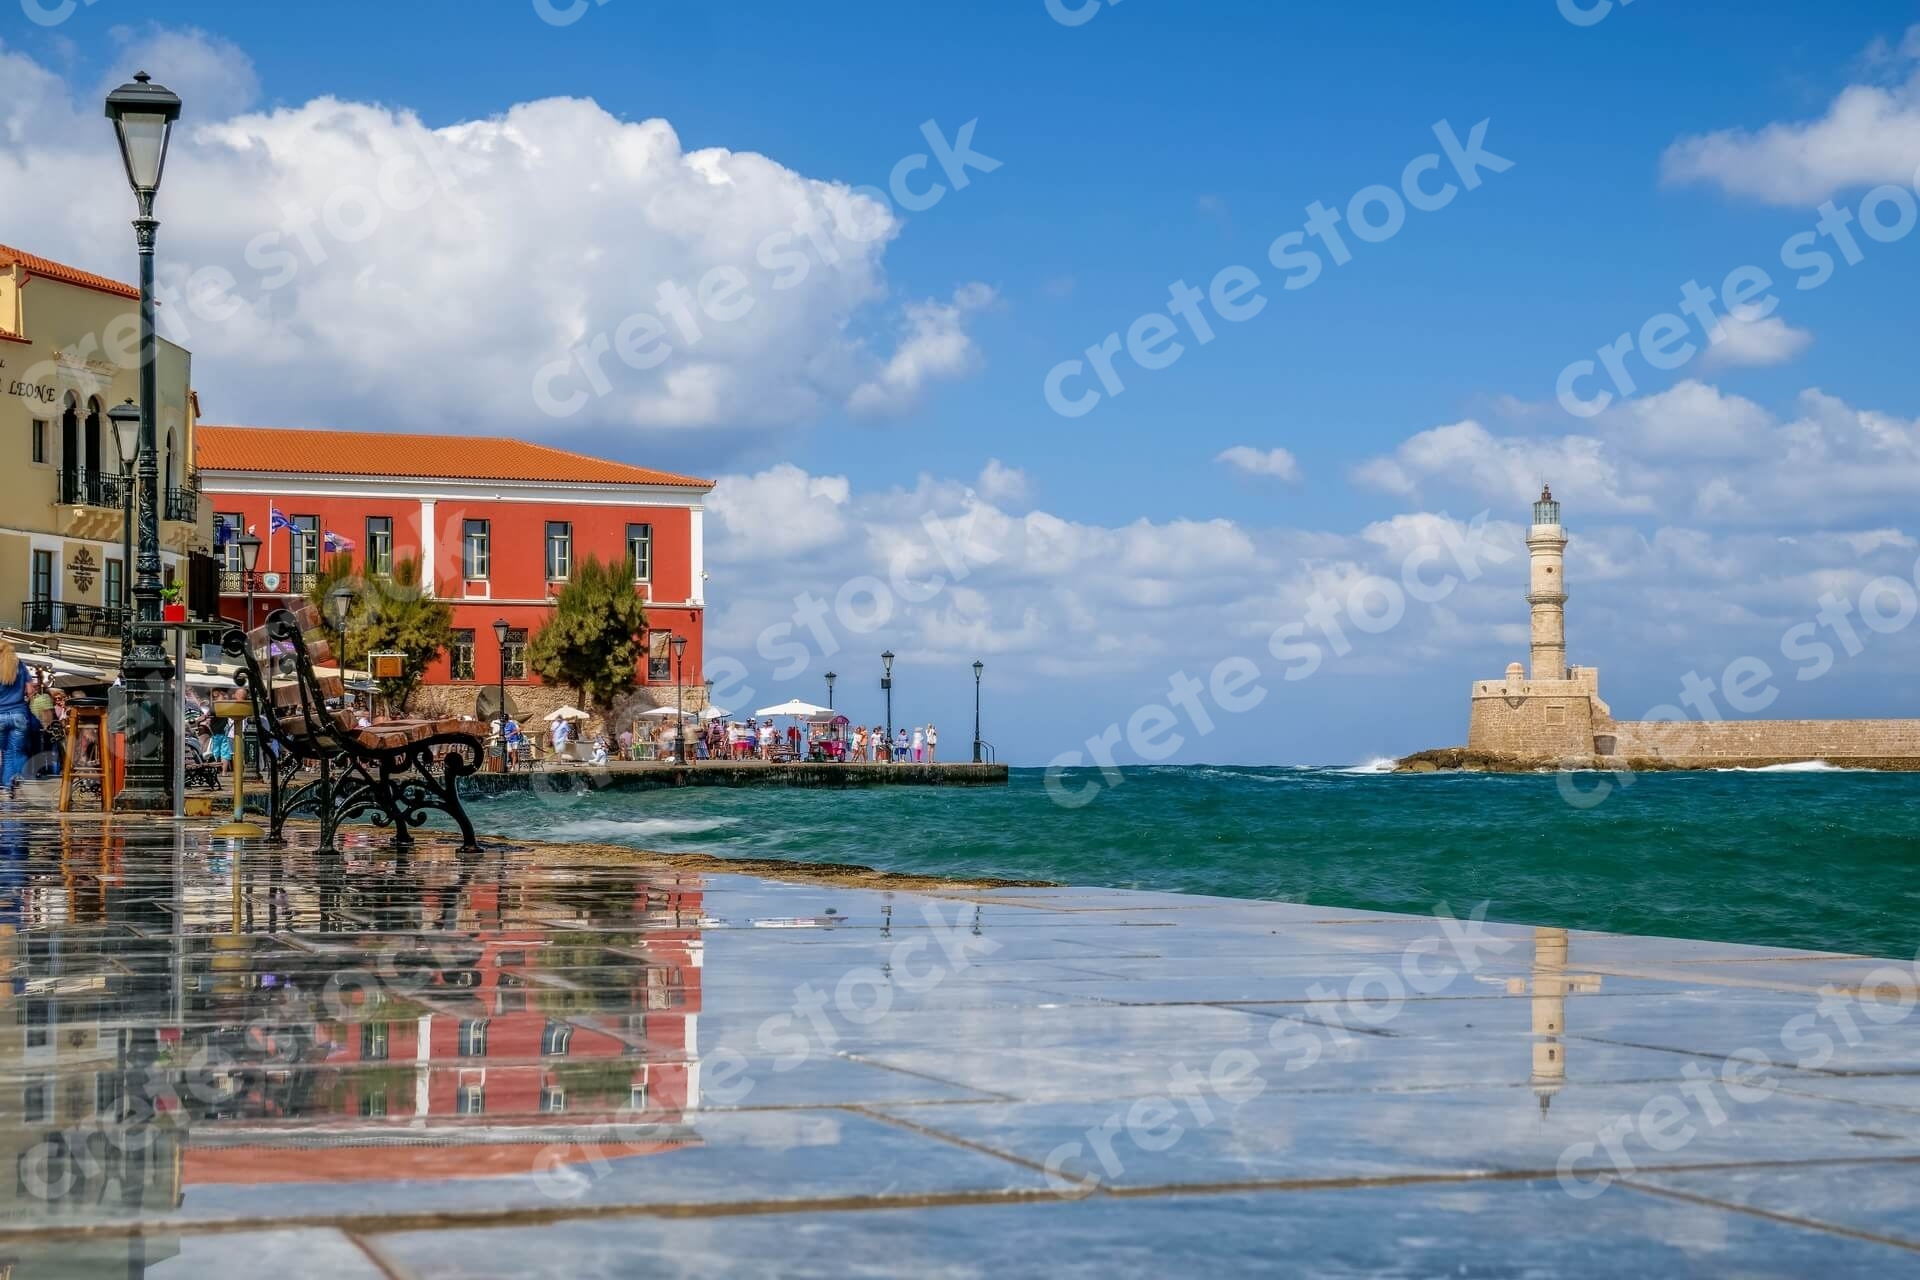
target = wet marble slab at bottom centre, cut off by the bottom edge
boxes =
[374,1182,1920,1280]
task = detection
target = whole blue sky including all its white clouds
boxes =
[0,0,1920,764]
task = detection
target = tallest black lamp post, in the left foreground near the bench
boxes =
[108,71,180,812]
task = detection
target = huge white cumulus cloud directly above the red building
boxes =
[0,31,991,441]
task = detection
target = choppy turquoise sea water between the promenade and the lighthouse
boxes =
[474,766,1920,958]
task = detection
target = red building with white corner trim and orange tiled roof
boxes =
[194,424,712,712]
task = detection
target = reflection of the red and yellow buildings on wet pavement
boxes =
[0,821,703,1276]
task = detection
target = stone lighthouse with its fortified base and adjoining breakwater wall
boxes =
[1467,489,1920,770]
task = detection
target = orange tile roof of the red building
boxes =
[194,424,714,489]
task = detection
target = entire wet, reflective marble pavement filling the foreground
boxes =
[0,816,1920,1280]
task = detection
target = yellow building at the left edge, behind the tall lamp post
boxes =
[0,244,213,633]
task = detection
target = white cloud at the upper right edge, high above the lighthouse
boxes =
[1663,27,1920,205]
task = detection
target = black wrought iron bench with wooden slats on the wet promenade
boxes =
[225,606,484,850]
